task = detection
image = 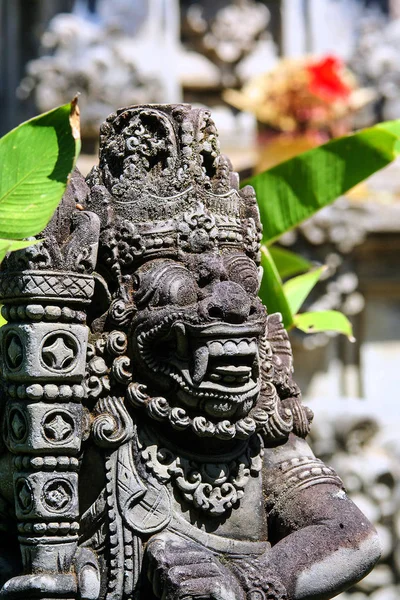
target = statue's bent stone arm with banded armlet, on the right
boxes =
[265,435,380,600]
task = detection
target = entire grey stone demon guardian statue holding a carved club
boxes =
[0,105,379,600]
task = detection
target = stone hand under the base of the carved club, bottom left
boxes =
[0,548,100,600]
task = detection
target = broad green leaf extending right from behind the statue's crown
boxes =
[243,120,400,243]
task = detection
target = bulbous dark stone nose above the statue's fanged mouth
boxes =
[205,281,251,323]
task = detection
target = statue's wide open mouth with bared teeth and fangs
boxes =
[137,320,264,416]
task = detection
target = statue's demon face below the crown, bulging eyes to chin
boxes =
[131,252,266,419]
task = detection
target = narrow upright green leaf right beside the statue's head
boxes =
[259,246,293,328]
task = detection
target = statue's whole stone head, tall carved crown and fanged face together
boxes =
[88,105,266,427]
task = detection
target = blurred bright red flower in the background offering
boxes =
[306,56,351,103]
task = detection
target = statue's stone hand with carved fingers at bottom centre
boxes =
[147,533,245,600]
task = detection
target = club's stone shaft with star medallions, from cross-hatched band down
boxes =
[1,296,90,573]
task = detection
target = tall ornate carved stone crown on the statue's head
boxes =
[87,105,261,271]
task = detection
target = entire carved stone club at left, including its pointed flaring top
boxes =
[0,173,98,597]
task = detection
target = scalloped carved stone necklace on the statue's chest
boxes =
[138,429,263,516]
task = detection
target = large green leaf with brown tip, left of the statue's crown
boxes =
[0,100,80,239]
